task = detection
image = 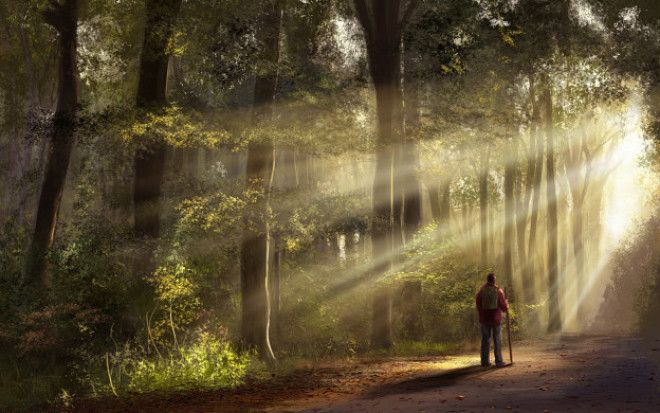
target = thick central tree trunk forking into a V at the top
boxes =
[354,0,415,348]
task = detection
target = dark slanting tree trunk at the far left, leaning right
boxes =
[24,0,78,288]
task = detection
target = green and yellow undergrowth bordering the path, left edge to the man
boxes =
[0,199,496,410]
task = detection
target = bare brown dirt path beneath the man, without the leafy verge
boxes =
[298,337,660,413]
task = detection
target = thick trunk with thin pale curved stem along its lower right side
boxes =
[241,0,282,361]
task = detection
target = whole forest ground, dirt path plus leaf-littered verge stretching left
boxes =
[69,336,660,413]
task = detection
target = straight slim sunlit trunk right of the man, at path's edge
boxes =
[543,82,561,333]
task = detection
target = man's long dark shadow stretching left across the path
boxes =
[364,365,494,398]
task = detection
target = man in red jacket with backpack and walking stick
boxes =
[477,273,509,367]
